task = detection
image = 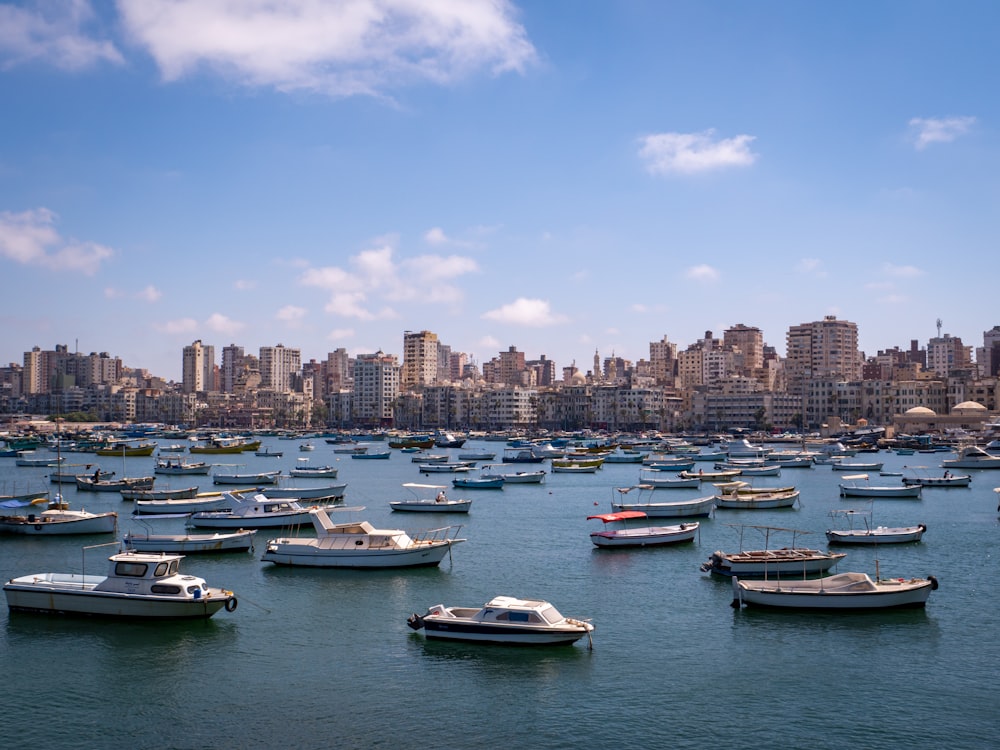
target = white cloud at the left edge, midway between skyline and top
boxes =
[0,208,114,276]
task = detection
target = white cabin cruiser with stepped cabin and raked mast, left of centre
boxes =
[261,508,465,568]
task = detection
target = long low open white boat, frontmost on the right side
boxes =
[733,572,938,611]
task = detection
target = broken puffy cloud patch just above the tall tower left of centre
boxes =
[300,244,479,320]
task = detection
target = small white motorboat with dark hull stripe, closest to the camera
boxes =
[406,596,594,646]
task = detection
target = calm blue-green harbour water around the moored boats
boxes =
[0,440,1000,748]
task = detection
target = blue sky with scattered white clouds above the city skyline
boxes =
[0,0,1000,379]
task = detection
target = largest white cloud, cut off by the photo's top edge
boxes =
[118,0,536,96]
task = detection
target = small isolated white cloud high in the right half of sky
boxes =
[639,130,757,175]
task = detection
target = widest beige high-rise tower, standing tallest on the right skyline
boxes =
[785,315,862,396]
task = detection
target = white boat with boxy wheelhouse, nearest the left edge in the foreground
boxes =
[3,552,237,619]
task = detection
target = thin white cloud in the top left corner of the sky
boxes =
[0,0,123,71]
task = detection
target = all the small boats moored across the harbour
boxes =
[0,434,1000,645]
